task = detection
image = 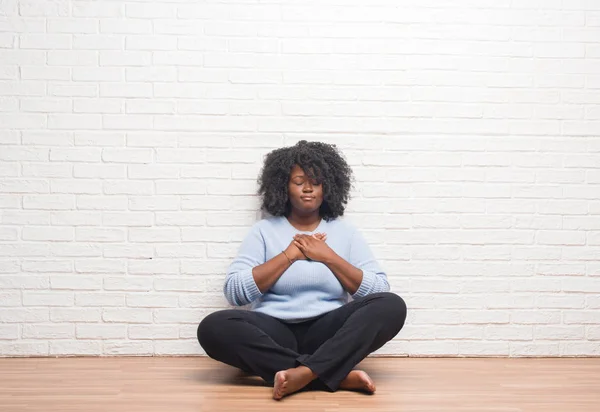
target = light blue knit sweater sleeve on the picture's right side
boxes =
[350,230,390,298]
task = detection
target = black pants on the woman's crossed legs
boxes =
[198,292,406,391]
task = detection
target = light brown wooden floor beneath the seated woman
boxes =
[0,357,600,412]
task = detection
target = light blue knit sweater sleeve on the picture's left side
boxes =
[223,222,266,306]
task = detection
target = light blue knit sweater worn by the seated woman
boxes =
[223,216,390,322]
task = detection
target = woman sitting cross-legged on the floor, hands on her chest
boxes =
[198,140,406,399]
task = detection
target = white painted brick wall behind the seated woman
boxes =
[0,0,600,356]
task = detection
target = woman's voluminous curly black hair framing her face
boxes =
[258,140,353,221]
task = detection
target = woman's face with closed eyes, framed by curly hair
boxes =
[288,165,323,215]
